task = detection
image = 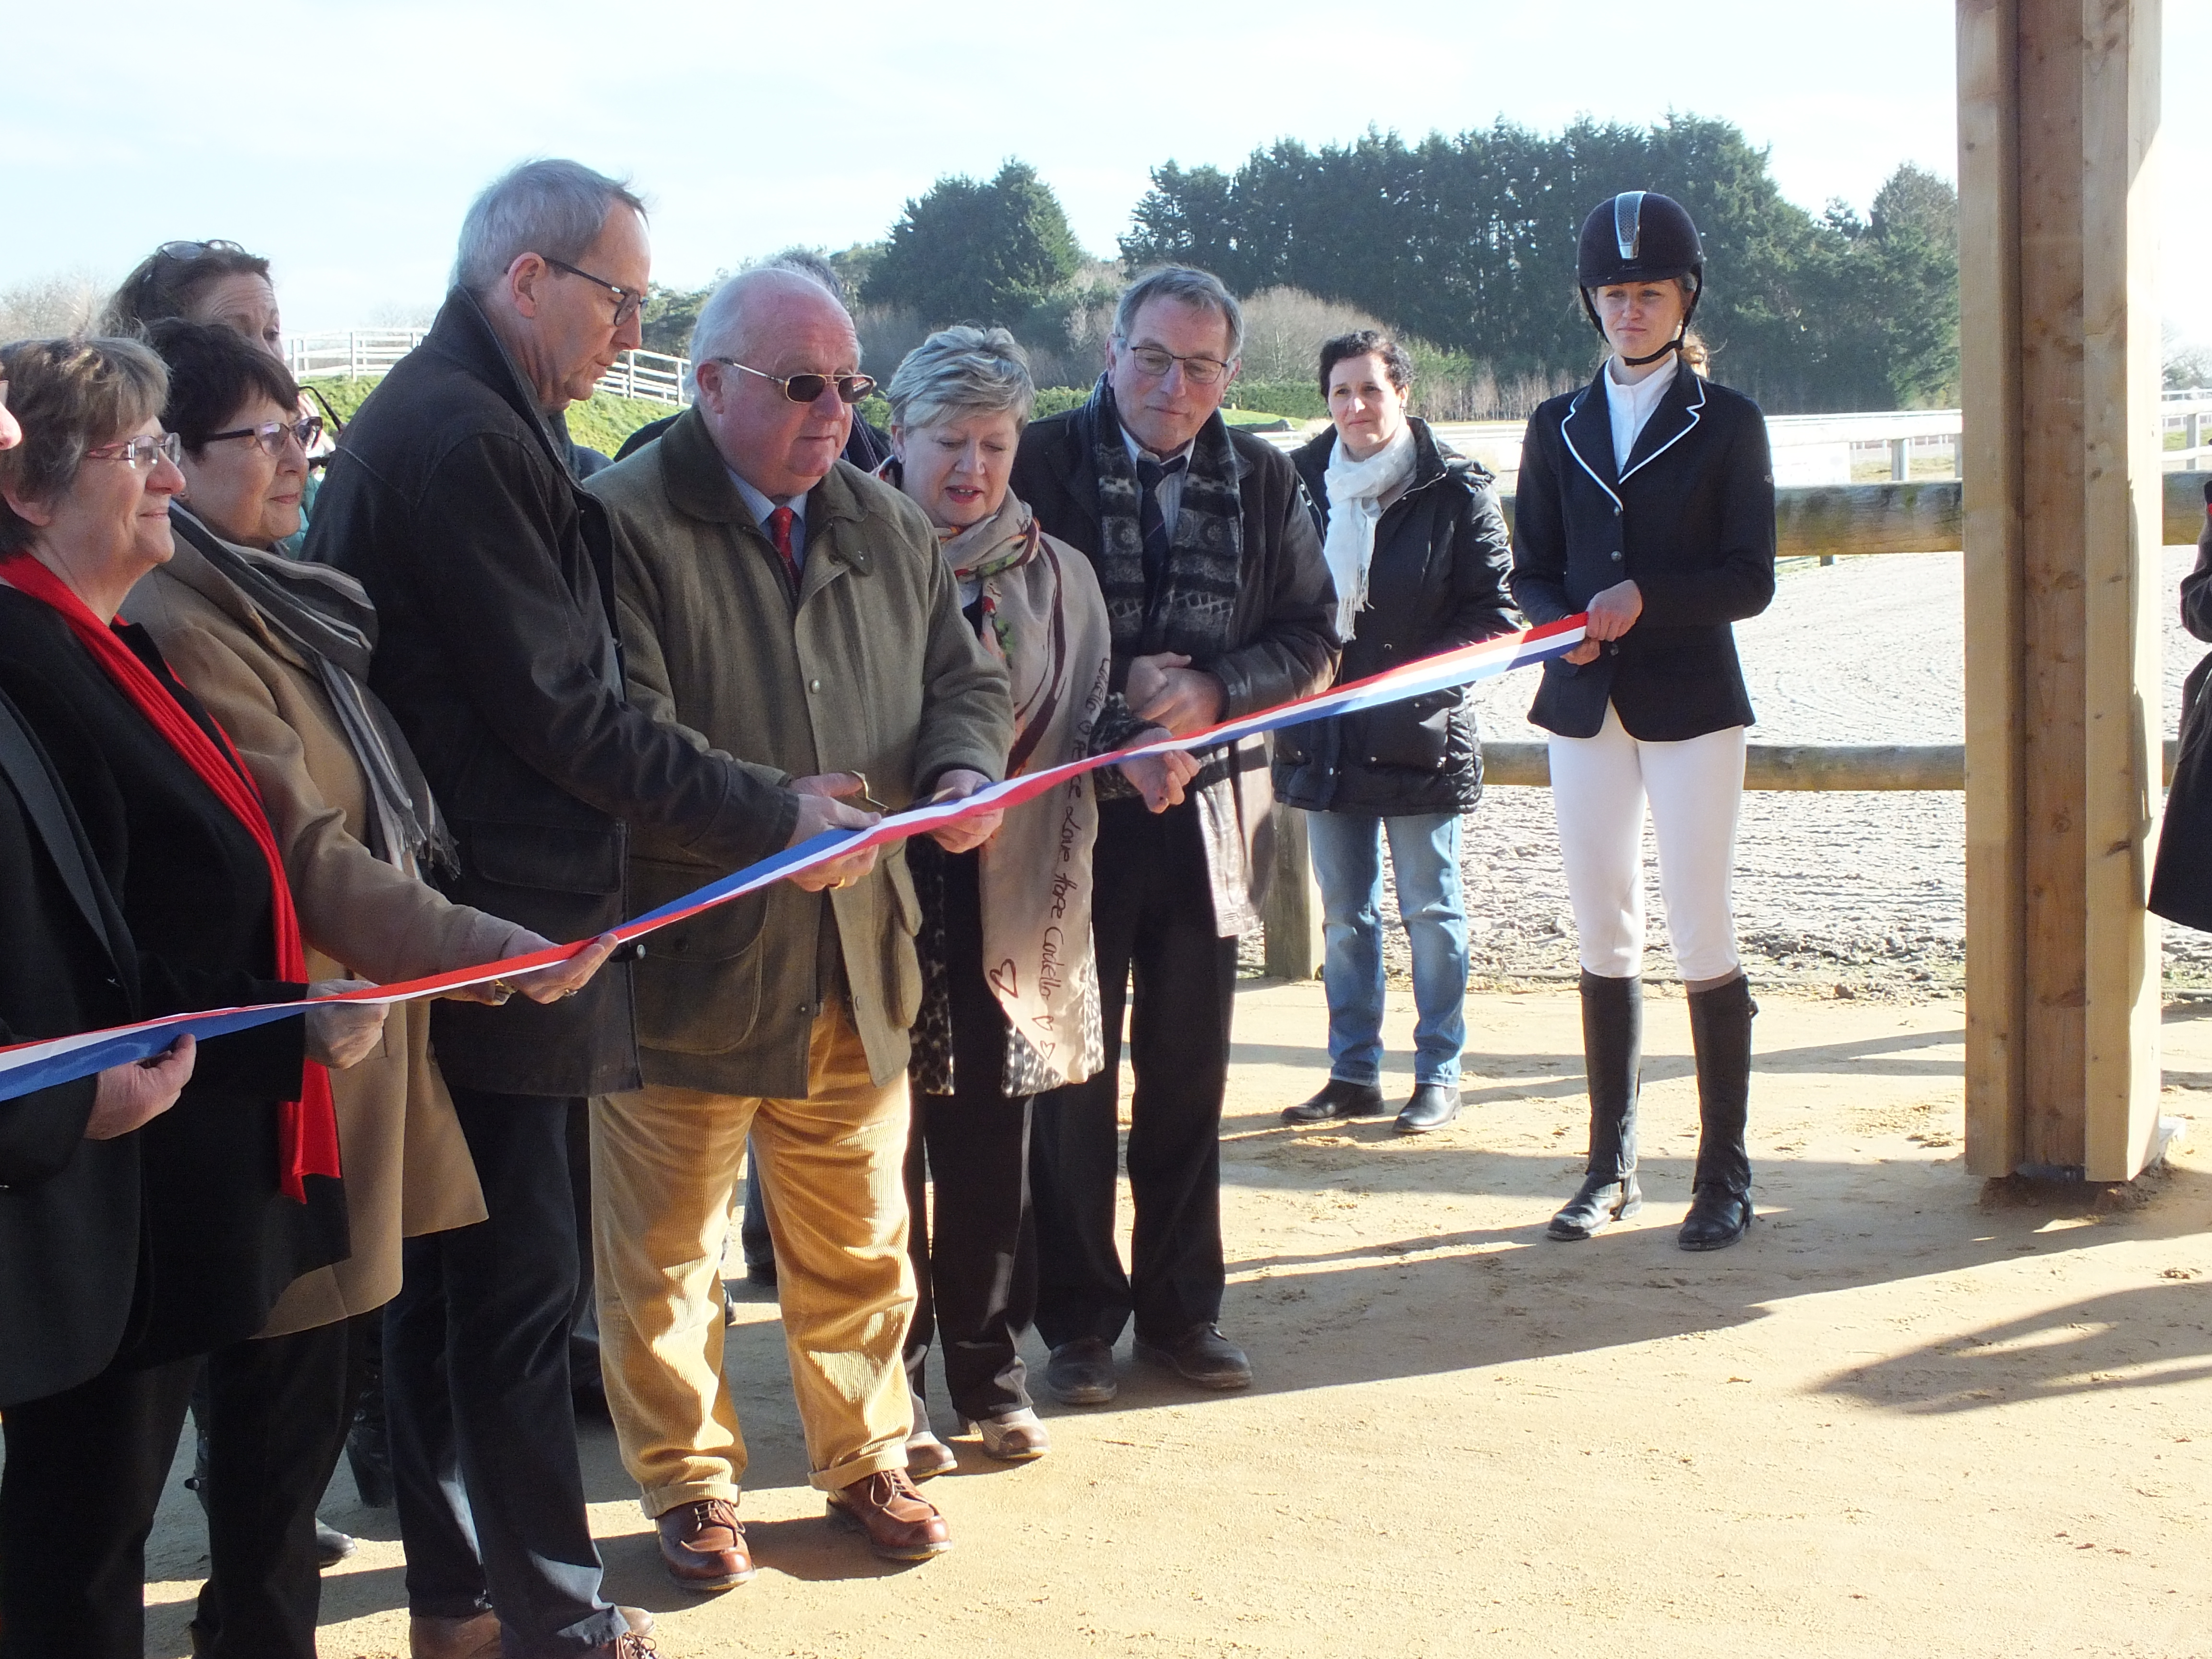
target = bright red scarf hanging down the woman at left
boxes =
[0,553,338,1203]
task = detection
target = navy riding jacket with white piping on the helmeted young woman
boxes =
[1513,363,1774,743]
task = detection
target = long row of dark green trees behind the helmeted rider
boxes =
[1121,115,1958,409]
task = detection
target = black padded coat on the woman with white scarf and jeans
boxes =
[1274,421,1520,818]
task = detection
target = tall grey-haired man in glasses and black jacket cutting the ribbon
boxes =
[308,161,869,1659]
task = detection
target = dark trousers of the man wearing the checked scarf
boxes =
[1029,801,1237,1347]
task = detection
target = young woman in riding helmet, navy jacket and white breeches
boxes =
[1513,190,1774,1250]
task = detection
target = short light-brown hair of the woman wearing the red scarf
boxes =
[0,338,168,553]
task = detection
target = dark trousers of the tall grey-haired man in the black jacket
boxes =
[385,1088,626,1659]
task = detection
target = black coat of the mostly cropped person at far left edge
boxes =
[0,697,142,1409]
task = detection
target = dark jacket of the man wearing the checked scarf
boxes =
[1013,403,1336,719]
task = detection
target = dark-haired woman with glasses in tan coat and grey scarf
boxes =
[124,321,613,1659]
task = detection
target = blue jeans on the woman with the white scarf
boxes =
[1305,812,1467,1086]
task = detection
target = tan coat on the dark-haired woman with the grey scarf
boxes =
[124,538,530,1336]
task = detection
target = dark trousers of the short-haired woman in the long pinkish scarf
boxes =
[907,854,1037,1429]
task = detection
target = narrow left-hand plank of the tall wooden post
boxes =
[1958,0,2026,1175]
